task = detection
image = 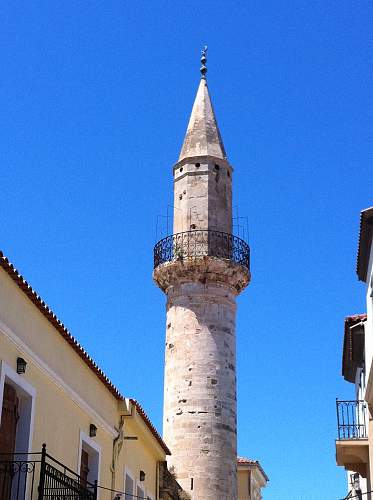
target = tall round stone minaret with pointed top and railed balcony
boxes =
[153,48,250,500]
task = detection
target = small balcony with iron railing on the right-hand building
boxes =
[336,400,369,477]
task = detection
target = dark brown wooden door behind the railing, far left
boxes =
[0,384,19,500]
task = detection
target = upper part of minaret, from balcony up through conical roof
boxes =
[153,73,250,293]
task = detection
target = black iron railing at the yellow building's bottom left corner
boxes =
[0,445,97,500]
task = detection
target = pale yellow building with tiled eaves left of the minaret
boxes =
[0,253,171,500]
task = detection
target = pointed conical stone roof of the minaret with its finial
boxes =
[179,47,227,161]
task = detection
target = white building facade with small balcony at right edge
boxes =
[336,207,373,500]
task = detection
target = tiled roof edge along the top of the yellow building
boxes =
[0,250,171,455]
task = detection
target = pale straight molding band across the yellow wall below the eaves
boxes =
[0,320,118,437]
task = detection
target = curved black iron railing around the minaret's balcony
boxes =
[154,229,250,269]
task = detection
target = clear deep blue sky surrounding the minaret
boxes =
[0,0,373,500]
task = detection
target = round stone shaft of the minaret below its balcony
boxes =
[164,282,237,500]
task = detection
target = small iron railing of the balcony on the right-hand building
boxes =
[336,399,367,440]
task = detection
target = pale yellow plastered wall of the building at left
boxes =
[0,269,165,499]
